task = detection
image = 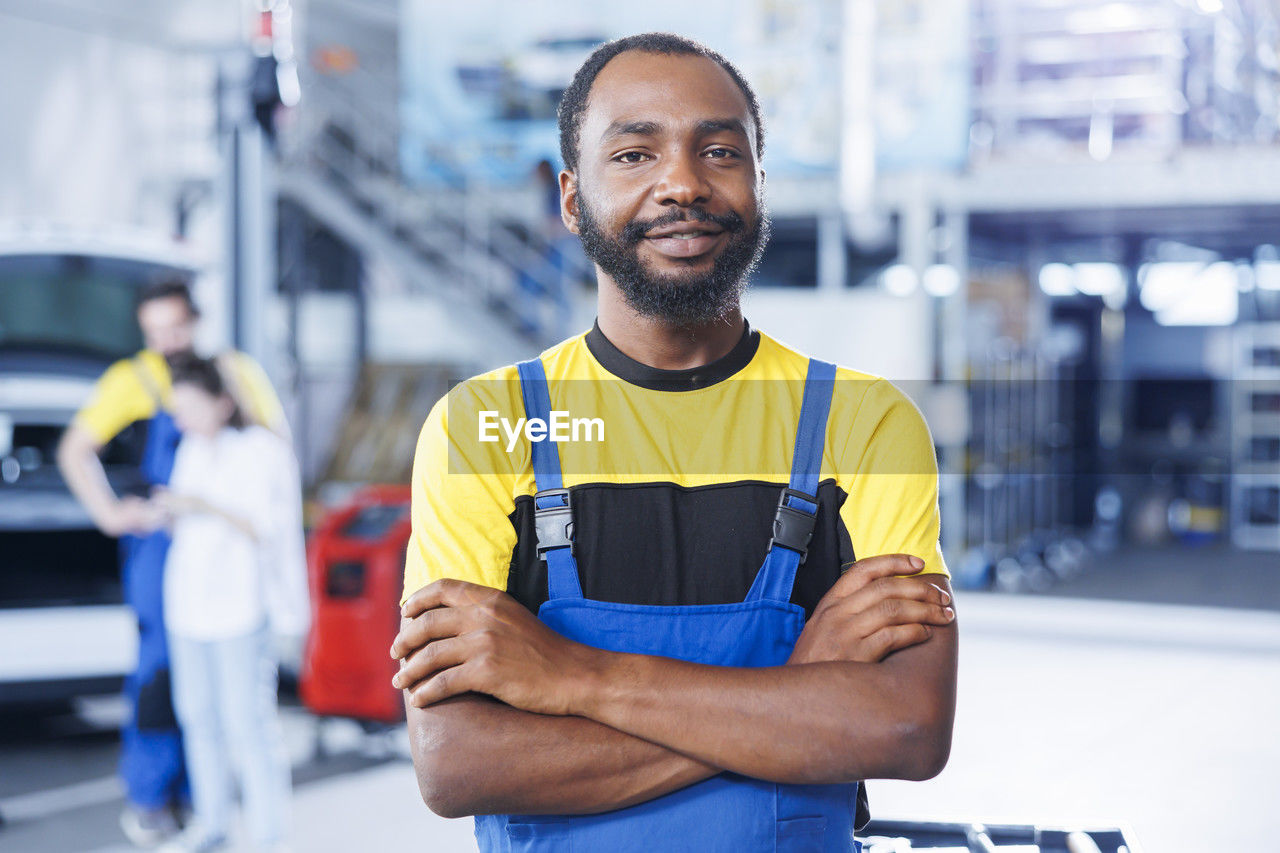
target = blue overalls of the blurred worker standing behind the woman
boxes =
[120,401,189,809]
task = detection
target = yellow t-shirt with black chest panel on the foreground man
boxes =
[404,320,947,611]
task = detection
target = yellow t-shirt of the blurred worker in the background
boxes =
[76,350,284,444]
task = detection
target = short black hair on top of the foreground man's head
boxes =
[557,32,764,172]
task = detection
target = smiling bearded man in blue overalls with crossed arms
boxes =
[390,35,957,852]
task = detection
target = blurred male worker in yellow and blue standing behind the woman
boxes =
[58,282,285,845]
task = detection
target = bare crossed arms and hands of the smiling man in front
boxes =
[392,555,956,817]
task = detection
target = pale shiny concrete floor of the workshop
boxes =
[0,540,1280,853]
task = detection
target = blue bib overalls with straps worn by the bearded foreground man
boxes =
[475,360,861,853]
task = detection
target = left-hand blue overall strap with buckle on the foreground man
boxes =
[516,359,582,598]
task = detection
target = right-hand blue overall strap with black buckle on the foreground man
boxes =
[746,359,836,602]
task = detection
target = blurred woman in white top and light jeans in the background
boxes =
[154,356,308,852]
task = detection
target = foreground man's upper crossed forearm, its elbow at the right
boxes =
[575,626,956,784]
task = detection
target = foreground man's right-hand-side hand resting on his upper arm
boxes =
[787,553,955,663]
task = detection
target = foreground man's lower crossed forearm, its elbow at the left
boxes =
[406,694,719,817]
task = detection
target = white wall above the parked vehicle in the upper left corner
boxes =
[0,0,239,232]
